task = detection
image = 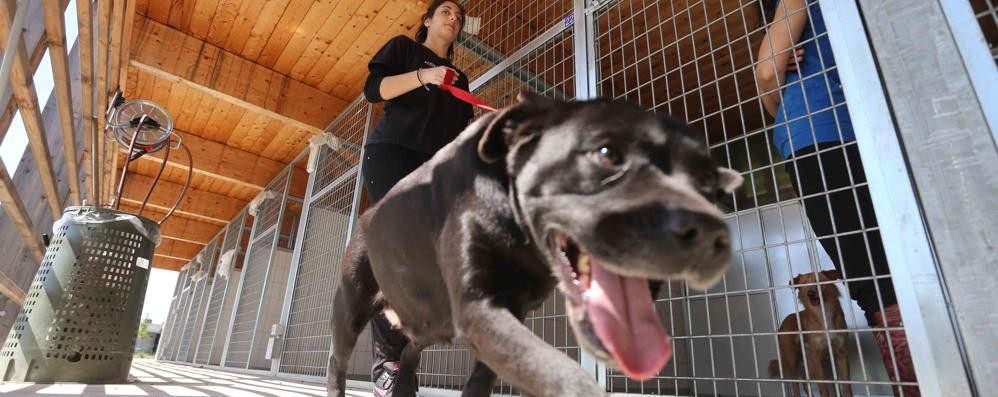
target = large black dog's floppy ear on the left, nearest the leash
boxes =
[478,91,553,163]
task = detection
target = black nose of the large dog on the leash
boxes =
[667,209,731,254]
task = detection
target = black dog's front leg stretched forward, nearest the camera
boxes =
[459,300,606,397]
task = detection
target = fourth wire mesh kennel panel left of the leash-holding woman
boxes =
[177,237,219,362]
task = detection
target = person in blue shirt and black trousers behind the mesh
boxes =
[756,0,919,396]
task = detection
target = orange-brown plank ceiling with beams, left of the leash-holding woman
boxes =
[116,0,426,269]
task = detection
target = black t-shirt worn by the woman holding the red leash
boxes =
[364,36,474,155]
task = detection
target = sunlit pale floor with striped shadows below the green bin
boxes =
[0,360,371,397]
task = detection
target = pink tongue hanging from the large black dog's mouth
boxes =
[585,262,672,380]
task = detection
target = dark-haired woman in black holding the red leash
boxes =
[362,0,474,397]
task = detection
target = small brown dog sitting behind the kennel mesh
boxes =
[769,270,852,397]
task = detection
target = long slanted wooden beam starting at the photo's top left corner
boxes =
[0,0,62,219]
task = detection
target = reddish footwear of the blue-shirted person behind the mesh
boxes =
[873,304,922,397]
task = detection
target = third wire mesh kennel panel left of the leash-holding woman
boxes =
[194,211,246,365]
